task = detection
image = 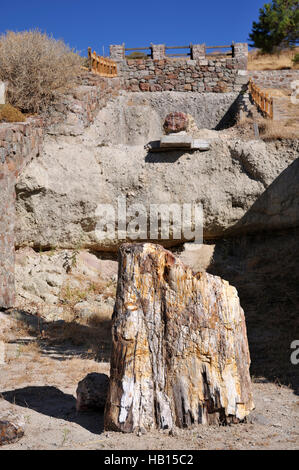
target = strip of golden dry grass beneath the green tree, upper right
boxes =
[248,47,299,70]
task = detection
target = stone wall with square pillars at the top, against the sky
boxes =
[110,43,248,93]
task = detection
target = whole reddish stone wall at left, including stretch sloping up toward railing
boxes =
[0,73,122,308]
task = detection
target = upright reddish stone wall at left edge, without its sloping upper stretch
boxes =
[0,118,44,308]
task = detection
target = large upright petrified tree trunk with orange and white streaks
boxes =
[105,243,254,432]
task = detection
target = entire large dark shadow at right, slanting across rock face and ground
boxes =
[208,159,299,394]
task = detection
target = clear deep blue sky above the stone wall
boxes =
[0,0,269,55]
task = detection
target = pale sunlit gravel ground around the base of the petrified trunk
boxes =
[0,343,299,450]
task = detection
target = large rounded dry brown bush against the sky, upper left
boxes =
[0,30,82,113]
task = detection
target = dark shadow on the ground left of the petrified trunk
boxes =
[0,386,104,434]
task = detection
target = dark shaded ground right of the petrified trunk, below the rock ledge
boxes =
[208,228,299,394]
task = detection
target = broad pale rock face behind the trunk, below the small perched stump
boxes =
[16,118,299,251]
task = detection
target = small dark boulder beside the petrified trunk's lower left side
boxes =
[76,372,109,411]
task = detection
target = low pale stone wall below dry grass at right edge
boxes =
[248,70,299,89]
